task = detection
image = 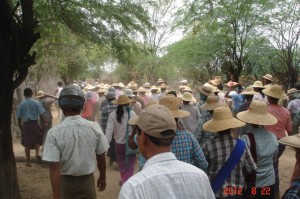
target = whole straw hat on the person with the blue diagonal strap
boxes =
[203,107,245,132]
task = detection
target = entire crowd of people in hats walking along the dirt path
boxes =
[17,74,300,199]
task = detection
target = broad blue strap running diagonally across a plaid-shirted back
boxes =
[211,139,246,193]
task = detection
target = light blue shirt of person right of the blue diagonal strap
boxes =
[241,127,278,187]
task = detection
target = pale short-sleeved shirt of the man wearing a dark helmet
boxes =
[43,115,109,176]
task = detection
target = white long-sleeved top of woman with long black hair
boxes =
[105,107,136,144]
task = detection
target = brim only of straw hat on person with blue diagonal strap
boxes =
[203,118,245,133]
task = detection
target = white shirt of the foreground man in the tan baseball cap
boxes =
[119,152,215,199]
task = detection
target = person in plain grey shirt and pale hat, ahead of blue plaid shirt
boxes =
[181,92,200,135]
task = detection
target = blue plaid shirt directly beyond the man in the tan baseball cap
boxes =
[171,129,208,171]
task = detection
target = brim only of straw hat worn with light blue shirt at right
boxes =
[237,110,278,125]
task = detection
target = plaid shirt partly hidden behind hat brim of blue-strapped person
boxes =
[195,112,216,147]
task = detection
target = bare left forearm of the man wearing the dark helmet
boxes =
[49,162,60,199]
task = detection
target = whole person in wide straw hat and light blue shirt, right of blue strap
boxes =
[237,100,278,198]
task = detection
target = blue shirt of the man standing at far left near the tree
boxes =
[17,98,45,122]
